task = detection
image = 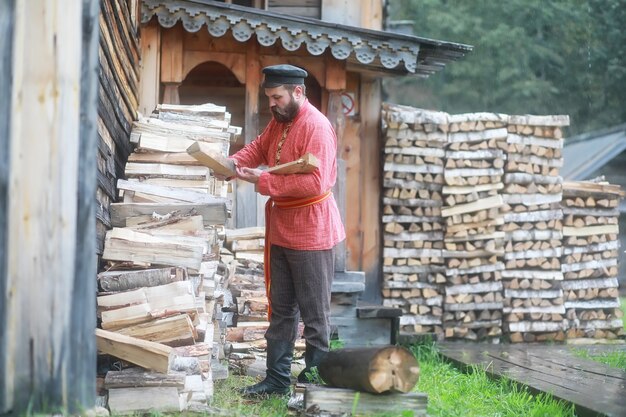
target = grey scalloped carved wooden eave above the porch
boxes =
[141,0,472,77]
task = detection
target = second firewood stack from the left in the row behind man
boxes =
[441,113,507,340]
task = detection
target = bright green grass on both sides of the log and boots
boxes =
[212,344,575,417]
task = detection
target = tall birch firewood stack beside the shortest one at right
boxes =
[502,116,569,342]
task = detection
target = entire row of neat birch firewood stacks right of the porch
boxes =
[382,104,621,342]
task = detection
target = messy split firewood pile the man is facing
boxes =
[97,104,240,414]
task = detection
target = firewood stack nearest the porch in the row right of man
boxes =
[382,105,448,336]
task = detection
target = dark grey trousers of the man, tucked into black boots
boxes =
[265,245,335,351]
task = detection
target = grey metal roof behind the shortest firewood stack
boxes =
[561,124,626,180]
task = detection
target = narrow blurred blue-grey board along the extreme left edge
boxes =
[0,0,15,414]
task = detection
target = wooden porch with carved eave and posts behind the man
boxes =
[139,0,471,300]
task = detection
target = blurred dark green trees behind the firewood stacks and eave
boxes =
[385,0,626,134]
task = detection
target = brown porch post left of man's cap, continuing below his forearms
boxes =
[235,39,262,228]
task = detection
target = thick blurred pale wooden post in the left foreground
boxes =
[0,0,99,415]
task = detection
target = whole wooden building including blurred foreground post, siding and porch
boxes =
[0,0,471,415]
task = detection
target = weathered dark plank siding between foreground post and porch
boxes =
[96,0,140,255]
